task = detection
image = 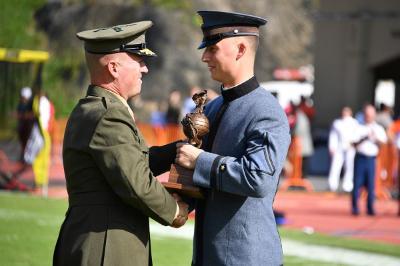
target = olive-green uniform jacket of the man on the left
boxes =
[53,86,176,265]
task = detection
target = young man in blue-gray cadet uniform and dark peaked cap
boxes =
[175,11,290,266]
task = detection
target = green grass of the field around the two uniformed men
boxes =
[0,192,400,266]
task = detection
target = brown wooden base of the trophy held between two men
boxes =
[162,164,203,198]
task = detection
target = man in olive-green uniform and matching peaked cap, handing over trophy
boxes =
[53,21,187,265]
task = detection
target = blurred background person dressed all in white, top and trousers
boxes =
[328,106,358,192]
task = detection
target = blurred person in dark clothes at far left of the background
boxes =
[17,87,33,161]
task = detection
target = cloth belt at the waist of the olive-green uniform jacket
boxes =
[68,191,123,207]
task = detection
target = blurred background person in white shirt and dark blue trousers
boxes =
[351,105,387,216]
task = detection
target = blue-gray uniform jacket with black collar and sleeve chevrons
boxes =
[192,77,290,266]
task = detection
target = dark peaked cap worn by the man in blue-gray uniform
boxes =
[197,11,267,49]
